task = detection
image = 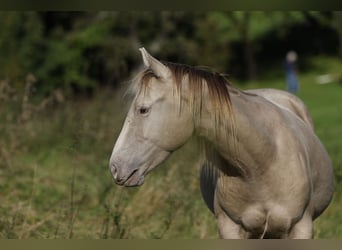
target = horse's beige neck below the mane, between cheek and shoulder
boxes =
[196,91,275,179]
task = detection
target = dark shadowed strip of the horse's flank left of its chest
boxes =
[200,161,219,213]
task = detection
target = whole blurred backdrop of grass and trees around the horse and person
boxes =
[0,11,342,238]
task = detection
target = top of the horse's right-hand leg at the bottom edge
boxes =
[289,212,313,239]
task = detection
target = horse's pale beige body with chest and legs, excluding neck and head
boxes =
[201,90,333,238]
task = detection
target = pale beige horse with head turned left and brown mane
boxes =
[109,48,334,239]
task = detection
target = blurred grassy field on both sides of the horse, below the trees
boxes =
[0,58,342,239]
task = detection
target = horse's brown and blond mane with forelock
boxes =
[134,61,236,141]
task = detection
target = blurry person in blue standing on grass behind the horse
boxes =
[285,50,299,94]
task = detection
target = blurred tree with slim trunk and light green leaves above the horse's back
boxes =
[202,11,305,80]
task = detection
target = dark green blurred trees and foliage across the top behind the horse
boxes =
[0,11,341,96]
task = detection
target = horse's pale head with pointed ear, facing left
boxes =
[109,48,194,186]
